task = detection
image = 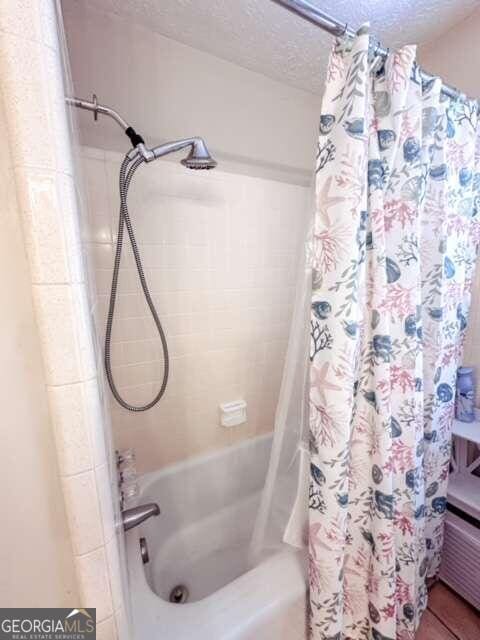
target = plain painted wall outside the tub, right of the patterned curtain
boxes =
[419,10,480,370]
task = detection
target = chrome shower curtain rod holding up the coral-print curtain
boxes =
[272,0,472,100]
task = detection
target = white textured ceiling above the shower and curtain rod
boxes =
[77,0,479,93]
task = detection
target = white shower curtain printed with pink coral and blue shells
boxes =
[309,25,480,640]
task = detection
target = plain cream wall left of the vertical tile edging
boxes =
[0,89,78,607]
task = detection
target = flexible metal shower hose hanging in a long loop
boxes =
[105,154,169,411]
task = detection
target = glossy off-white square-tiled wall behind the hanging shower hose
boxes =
[83,148,308,471]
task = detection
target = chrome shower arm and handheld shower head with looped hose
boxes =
[66,94,217,411]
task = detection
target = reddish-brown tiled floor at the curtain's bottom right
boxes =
[415,582,480,640]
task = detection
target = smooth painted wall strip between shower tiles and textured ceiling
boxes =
[63,0,320,182]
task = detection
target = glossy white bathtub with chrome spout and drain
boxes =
[126,436,306,640]
